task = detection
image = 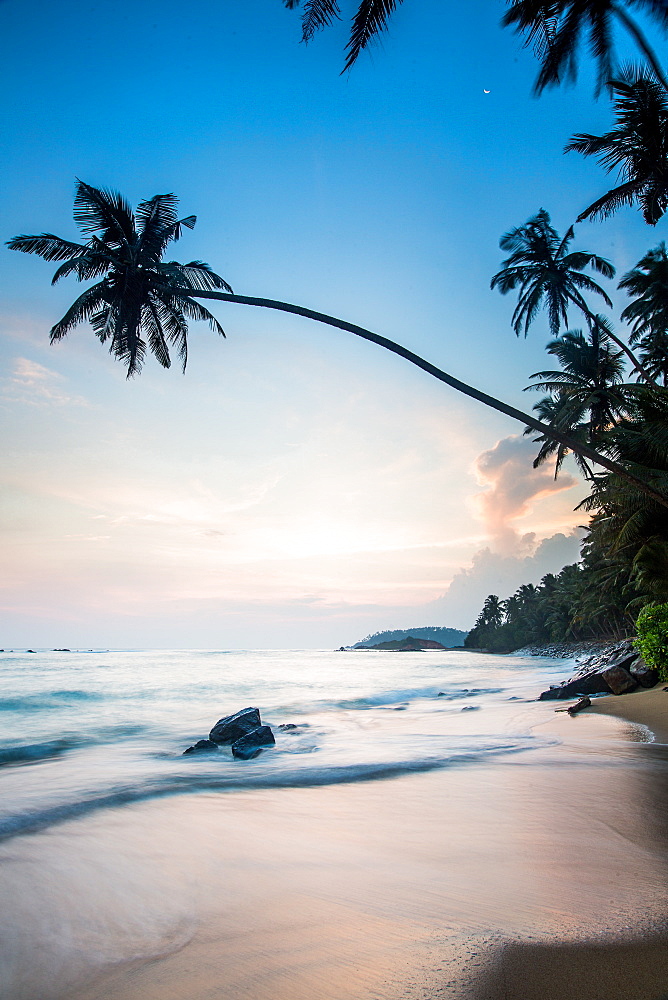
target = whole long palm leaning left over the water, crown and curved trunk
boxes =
[7,181,668,507]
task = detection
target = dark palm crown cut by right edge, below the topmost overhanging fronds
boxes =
[565,67,668,226]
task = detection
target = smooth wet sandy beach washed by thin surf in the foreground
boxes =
[0,654,668,1000]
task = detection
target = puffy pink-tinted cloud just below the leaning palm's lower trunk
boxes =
[475,435,577,555]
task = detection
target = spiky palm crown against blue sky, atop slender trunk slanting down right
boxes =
[490,208,615,337]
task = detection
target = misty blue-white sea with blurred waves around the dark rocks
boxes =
[0,649,616,838]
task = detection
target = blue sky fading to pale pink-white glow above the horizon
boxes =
[0,0,653,648]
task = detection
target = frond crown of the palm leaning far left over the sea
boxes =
[7,181,232,378]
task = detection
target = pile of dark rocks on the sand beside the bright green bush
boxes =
[539,640,658,701]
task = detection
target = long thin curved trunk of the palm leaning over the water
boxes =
[188,290,668,507]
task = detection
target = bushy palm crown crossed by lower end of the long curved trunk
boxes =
[525,318,628,479]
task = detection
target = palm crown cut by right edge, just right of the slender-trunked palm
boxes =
[619,242,668,386]
